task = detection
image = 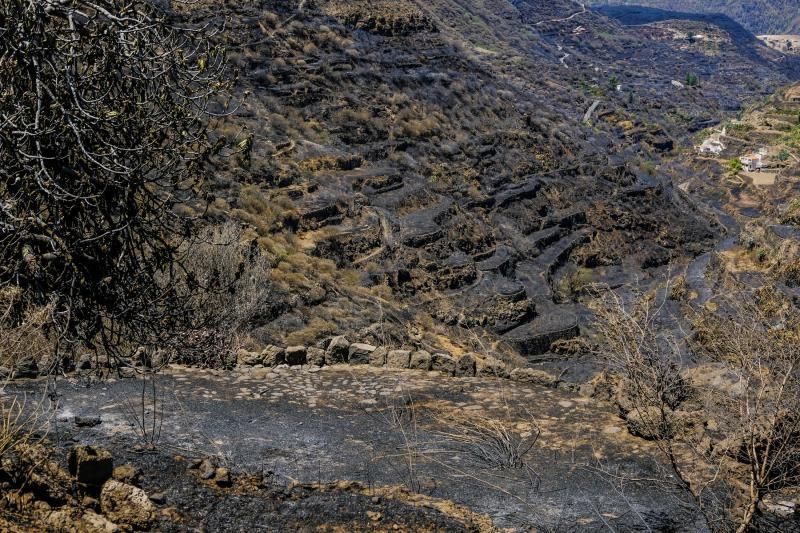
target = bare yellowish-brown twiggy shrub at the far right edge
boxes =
[694,288,800,532]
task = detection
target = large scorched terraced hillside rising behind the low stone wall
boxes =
[184,0,793,357]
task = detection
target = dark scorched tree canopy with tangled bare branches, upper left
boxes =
[0,0,229,358]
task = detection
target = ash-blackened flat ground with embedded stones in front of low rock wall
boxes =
[13,366,704,531]
